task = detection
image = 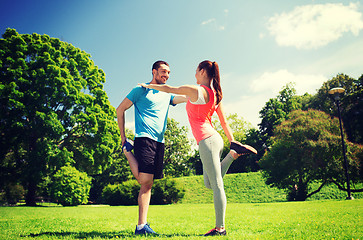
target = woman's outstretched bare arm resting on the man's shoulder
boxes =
[139,83,198,102]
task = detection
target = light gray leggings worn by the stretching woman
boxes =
[199,133,234,227]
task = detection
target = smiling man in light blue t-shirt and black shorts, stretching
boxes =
[117,61,187,234]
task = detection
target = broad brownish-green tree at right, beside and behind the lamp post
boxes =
[260,110,363,201]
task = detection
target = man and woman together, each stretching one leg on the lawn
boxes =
[117,61,257,236]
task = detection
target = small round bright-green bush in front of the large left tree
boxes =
[50,165,91,206]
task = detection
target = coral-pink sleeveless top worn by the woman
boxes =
[186,85,217,144]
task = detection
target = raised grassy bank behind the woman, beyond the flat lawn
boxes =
[176,172,363,203]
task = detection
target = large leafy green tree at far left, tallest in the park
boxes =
[0,29,120,205]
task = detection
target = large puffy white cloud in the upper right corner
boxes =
[267,3,363,49]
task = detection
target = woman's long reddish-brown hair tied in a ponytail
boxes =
[198,60,223,105]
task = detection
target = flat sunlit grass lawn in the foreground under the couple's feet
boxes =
[0,199,363,239]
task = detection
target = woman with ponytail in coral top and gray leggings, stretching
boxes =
[140,60,257,236]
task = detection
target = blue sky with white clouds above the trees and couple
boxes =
[0,0,363,136]
